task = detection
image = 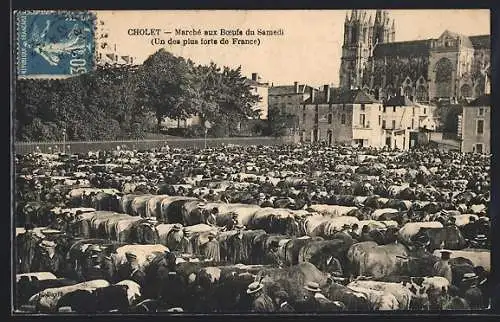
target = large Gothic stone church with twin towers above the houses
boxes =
[340,10,491,102]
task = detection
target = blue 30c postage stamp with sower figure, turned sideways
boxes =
[16,11,95,78]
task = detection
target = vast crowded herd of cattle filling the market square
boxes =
[14,146,492,313]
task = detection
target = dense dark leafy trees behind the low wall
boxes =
[14,49,261,141]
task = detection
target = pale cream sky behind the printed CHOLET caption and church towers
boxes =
[97,10,490,86]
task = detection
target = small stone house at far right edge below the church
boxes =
[458,95,491,154]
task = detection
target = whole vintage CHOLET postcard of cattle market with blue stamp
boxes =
[11,9,492,315]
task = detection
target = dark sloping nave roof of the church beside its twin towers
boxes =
[373,39,431,57]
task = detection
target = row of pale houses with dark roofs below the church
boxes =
[268,82,490,153]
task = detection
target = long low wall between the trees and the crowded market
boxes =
[14,137,293,154]
